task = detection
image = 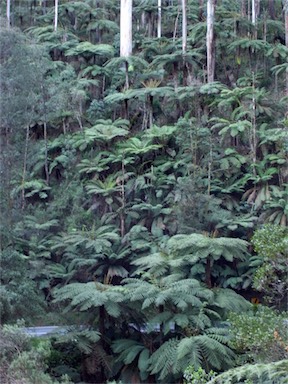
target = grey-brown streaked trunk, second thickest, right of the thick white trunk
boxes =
[206,0,217,83]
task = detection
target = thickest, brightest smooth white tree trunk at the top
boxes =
[120,0,132,57]
